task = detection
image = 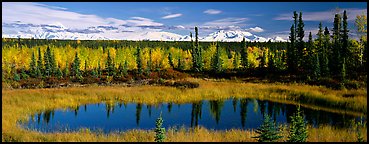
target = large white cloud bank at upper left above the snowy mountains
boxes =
[2,2,163,29]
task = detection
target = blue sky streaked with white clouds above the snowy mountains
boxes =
[2,2,367,38]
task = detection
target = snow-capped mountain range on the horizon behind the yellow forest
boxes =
[2,23,286,42]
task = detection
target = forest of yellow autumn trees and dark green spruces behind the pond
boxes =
[2,11,367,89]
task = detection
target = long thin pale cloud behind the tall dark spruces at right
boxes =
[274,8,367,21]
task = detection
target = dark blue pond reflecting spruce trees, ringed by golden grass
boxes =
[21,98,366,133]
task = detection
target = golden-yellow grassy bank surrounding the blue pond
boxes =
[2,79,367,141]
